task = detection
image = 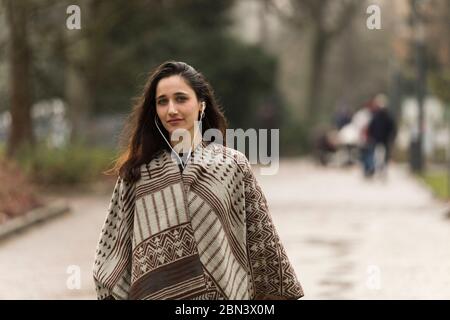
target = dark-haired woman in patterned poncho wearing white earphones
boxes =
[94,62,303,299]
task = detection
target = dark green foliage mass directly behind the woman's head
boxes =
[76,0,276,128]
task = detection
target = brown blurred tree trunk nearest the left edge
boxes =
[5,0,34,158]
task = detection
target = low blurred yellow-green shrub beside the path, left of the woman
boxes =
[13,143,115,185]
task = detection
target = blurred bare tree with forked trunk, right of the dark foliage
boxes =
[265,0,363,127]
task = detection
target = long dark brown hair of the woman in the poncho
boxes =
[105,61,227,183]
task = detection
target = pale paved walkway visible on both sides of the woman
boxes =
[0,160,450,299]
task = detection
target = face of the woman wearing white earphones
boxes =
[156,75,201,139]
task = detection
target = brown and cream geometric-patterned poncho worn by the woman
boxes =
[93,142,303,300]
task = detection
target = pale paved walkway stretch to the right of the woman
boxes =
[260,162,450,299]
